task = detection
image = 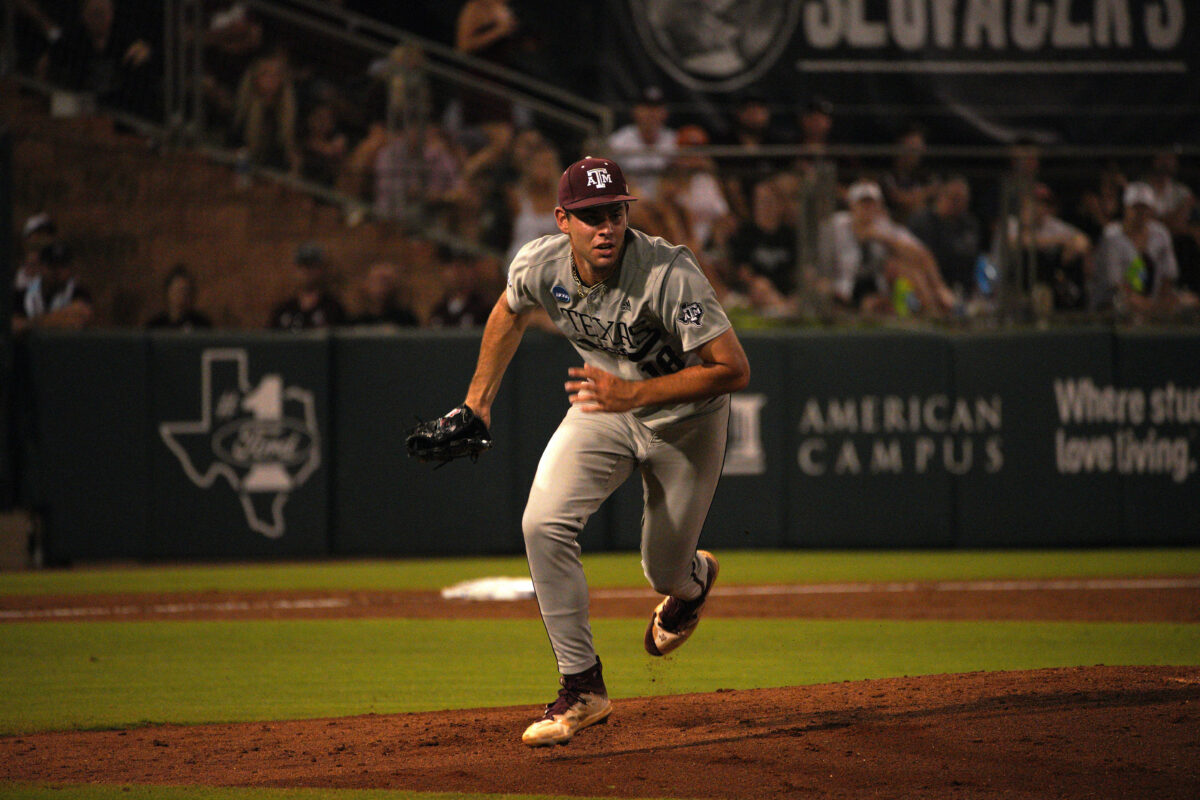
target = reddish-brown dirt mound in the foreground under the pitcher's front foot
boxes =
[0,667,1200,800]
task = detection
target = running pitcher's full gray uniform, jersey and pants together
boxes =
[508,229,730,674]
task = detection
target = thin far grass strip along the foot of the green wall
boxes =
[0,548,1200,595]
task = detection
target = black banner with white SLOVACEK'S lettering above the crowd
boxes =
[601,0,1200,146]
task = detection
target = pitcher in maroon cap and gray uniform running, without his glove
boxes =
[456,157,750,747]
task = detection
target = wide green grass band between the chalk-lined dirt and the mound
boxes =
[0,618,1200,733]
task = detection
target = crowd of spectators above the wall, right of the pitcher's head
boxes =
[608,90,1200,320]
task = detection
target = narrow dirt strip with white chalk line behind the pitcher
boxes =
[7,578,1200,622]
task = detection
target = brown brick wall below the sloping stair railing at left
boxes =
[0,82,468,327]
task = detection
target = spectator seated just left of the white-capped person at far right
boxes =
[994,184,1092,311]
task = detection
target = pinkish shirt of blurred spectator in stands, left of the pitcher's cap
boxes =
[373,125,461,221]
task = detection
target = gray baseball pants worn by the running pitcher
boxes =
[522,405,730,675]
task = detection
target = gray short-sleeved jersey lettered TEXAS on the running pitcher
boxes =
[508,228,730,431]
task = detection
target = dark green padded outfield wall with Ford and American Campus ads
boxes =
[17,329,1200,561]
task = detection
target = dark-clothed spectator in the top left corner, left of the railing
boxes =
[47,0,161,114]
